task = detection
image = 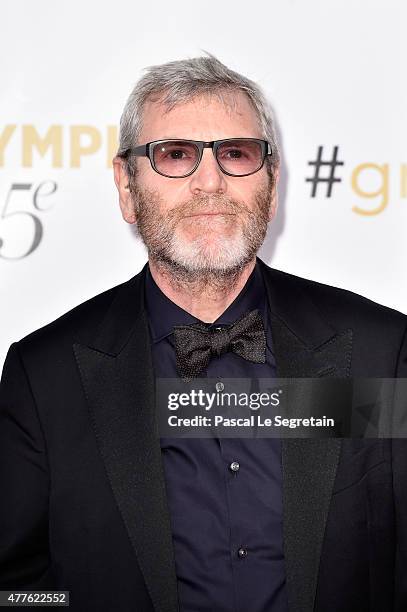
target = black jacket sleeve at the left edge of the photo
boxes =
[0,343,53,590]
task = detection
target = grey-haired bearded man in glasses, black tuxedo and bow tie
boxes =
[0,56,407,612]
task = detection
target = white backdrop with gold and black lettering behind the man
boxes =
[0,0,407,367]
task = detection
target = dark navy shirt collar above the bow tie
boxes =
[145,262,266,343]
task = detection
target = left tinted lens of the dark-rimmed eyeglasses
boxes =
[153,140,199,177]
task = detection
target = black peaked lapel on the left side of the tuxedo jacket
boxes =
[74,271,178,612]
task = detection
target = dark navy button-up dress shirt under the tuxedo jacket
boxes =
[145,264,288,612]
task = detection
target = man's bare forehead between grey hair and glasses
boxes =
[139,92,262,143]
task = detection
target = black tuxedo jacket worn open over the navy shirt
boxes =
[0,260,407,612]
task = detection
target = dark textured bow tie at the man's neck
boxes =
[174,310,266,380]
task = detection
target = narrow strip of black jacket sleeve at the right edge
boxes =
[392,328,407,612]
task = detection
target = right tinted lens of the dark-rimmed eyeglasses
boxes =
[217,139,263,176]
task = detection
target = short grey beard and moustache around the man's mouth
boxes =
[130,182,272,297]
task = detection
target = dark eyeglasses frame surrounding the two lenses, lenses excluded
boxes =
[121,138,273,178]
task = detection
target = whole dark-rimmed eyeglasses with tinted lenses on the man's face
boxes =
[123,138,272,178]
